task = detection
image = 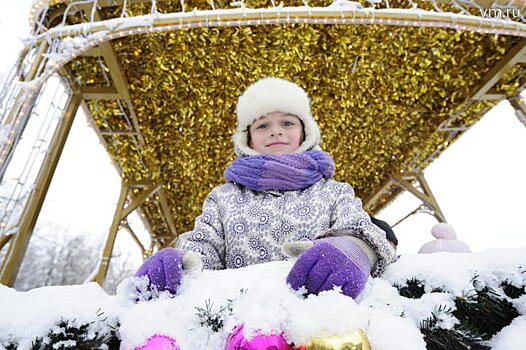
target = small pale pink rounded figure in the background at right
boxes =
[418,223,471,254]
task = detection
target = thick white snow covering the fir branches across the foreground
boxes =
[0,248,526,350]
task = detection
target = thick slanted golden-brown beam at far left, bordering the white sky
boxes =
[0,94,82,286]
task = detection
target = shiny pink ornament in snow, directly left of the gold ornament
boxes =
[225,325,293,350]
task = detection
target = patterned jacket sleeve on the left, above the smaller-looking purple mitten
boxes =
[175,189,225,270]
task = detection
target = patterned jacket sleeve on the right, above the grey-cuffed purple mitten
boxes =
[322,183,397,277]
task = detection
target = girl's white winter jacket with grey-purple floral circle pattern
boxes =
[176,178,396,276]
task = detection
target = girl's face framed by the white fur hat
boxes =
[249,112,304,154]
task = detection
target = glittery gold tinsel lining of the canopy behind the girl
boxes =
[56,13,524,239]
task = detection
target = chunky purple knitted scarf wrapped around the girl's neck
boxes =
[224,151,336,191]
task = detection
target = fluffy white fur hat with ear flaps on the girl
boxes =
[232,77,320,156]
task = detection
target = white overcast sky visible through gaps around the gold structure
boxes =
[0,0,526,266]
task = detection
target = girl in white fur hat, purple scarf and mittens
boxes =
[137,78,396,298]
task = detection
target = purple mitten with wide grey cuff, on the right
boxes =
[287,237,371,298]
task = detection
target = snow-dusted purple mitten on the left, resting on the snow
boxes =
[135,248,183,294]
